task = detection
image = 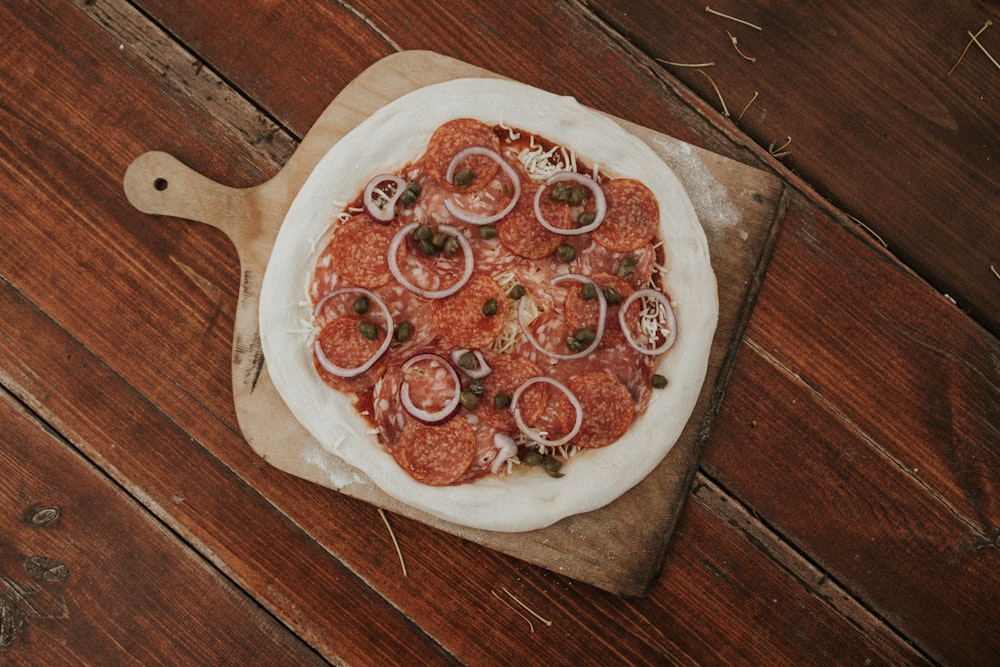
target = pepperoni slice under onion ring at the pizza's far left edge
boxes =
[313,315,385,392]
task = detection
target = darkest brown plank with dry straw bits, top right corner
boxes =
[588,0,1000,335]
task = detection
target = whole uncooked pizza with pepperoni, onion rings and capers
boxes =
[260,79,717,531]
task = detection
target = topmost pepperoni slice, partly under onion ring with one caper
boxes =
[424,118,500,192]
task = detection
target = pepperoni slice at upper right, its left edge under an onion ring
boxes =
[591,178,660,252]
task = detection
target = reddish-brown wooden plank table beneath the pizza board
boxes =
[0,0,1000,665]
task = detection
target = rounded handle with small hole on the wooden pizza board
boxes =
[123,151,248,237]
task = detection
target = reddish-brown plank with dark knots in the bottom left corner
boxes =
[0,386,325,665]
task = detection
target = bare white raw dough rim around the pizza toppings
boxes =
[254,79,718,532]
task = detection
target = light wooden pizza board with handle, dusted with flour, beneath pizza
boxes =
[124,51,785,596]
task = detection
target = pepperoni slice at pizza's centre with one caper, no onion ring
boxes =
[431,273,510,349]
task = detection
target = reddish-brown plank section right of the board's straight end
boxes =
[703,205,1000,664]
